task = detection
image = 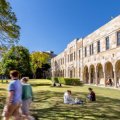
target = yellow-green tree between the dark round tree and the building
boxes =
[31,52,50,78]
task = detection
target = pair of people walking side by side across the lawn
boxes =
[2,70,34,120]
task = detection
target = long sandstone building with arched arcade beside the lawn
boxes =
[51,16,120,87]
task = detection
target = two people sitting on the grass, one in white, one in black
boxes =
[64,88,96,104]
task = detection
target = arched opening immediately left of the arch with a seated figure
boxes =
[96,63,105,85]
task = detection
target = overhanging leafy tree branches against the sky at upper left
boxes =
[0,0,20,47]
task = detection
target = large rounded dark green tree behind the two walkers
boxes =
[2,46,31,76]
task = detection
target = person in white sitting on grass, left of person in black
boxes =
[64,90,75,104]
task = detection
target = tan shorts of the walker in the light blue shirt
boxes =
[2,103,21,117]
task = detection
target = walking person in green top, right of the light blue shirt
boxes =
[21,77,33,120]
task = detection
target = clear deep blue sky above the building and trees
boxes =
[8,0,120,54]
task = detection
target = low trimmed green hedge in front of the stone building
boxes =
[53,77,83,86]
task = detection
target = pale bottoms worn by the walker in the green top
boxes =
[22,98,32,115]
